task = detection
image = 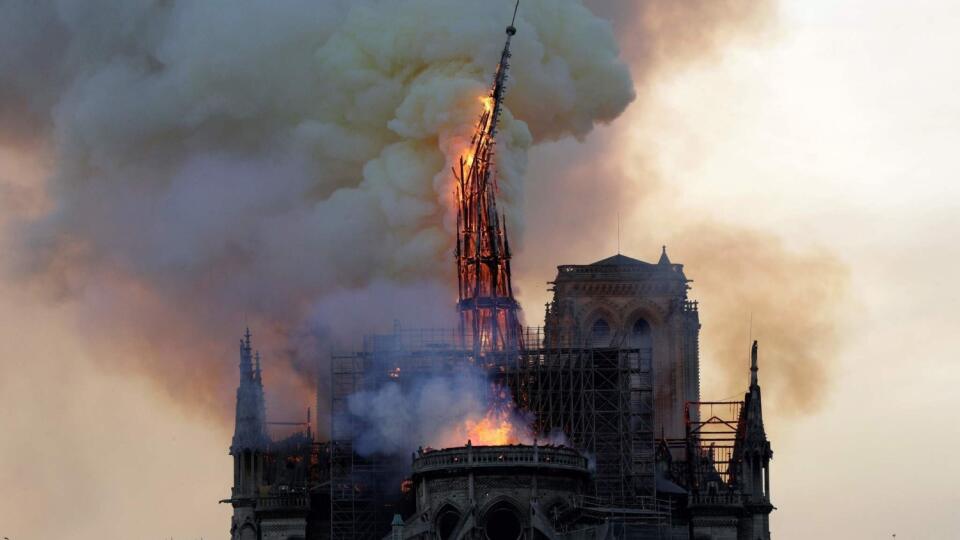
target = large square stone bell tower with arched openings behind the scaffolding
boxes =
[545,247,700,438]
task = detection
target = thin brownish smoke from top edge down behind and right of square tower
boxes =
[514,0,849,414]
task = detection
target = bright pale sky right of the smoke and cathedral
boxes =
[525,0,960,539]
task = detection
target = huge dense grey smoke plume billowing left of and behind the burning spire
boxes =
[0,0,634,424]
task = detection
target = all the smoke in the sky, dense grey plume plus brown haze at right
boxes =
[0,0,845,426]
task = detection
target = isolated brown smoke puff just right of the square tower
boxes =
[670,221,848,414]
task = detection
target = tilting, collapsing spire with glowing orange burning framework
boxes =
[453,0,522,356]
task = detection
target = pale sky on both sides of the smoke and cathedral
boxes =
[0,0,960,540]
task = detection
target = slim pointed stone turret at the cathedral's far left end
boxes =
[230,329,270,540]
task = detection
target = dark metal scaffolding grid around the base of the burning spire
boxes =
[330,328,670,540]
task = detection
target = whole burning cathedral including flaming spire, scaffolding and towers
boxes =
[221,5,773,540]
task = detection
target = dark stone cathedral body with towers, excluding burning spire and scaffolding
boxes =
[224,250,774,540]
